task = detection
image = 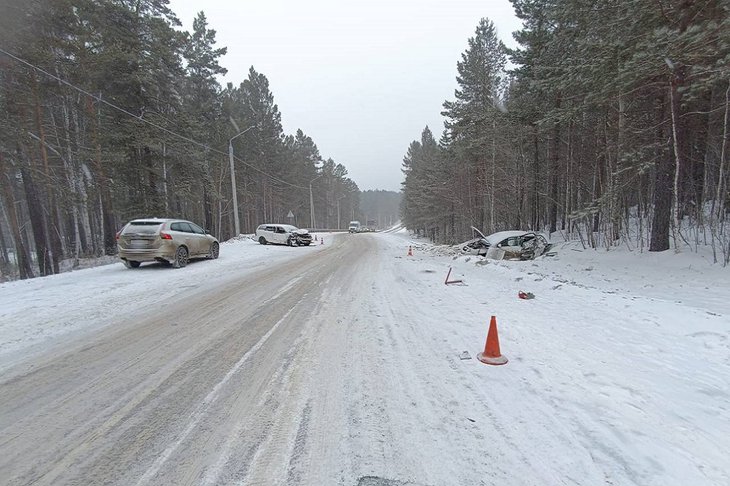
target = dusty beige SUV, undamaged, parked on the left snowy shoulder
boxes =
[117,218,220,268]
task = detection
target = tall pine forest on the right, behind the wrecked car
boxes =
[402,0,730,264]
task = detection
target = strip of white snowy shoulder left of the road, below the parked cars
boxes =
[0,237,326,369]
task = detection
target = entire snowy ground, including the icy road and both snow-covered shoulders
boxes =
[0,234,730,486]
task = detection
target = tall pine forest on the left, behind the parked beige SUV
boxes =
[0,0,359,280]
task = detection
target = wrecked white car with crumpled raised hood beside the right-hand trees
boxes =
[460,227,555,260]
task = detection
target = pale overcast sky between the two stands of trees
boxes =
[170,0,520,191]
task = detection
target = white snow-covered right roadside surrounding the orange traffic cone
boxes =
[382,233,730,486]
